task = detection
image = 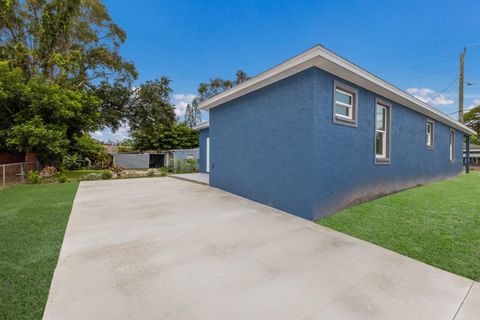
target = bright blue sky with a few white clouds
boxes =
[93,0,480,140]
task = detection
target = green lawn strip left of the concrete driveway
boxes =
[0,183,78,319]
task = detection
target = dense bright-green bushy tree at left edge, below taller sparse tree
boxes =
[0,62,100,164]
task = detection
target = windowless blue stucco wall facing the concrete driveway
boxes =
[210,70,315,219]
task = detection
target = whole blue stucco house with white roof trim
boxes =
[199,46,475,219]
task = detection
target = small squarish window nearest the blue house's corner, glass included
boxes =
[333,81,358,126]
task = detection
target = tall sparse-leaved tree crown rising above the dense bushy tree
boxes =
[0,0,137,88]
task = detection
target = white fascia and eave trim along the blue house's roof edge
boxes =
[199,45,476,135]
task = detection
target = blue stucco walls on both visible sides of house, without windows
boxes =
[208,68,463,219]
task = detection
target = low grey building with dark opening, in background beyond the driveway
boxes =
[112,148,199,169]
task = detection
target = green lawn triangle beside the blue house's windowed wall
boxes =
[317,171,480,281]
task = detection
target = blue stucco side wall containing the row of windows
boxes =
[313,69,464,219]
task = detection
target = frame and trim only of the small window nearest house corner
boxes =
[333,80,358,127]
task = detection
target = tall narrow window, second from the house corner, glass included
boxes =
[375,100,390,163]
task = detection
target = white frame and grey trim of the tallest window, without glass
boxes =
[373,98,392,164]
